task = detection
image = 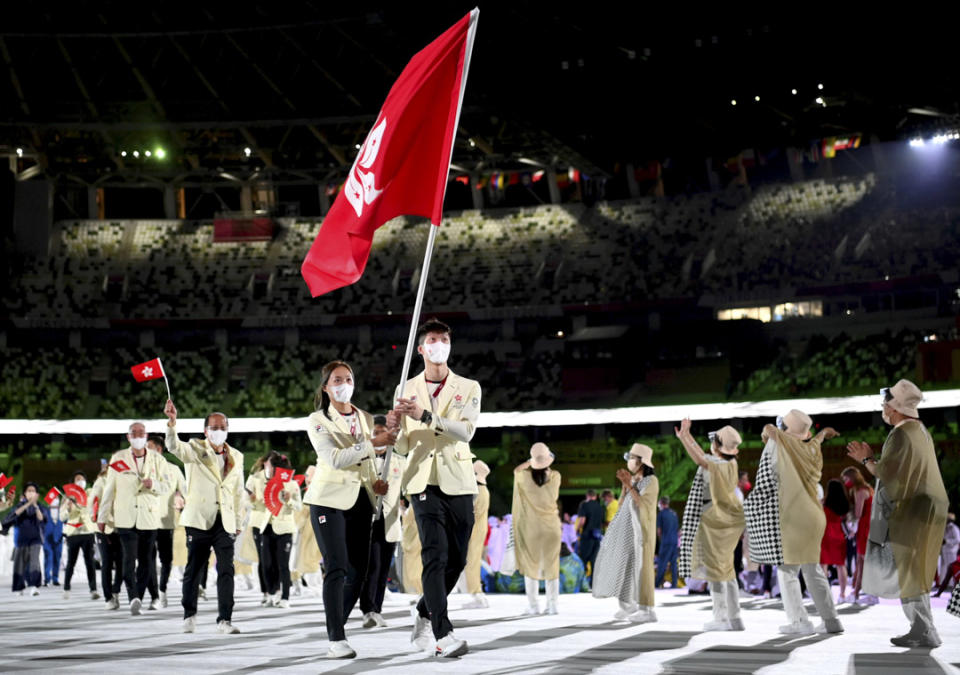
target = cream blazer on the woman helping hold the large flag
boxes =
[303,405,377,511]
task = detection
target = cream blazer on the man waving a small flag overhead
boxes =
[166,424,243,534]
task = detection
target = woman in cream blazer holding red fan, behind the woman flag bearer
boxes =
[251,451,302,609]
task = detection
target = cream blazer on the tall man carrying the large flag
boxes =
[396,371,480,495]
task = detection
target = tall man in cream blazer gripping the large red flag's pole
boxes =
[388,319,480,657]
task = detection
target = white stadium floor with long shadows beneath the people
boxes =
[0,572,960,675]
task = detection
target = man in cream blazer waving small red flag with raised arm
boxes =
[163,400,244,634]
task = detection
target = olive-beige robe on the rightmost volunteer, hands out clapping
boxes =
[876,420,948,598]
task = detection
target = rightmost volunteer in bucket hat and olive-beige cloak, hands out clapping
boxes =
[847,380,948,647]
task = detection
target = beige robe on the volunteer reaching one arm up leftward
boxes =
[691,459,746,581]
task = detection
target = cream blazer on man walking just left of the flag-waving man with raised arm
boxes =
[97,448,169,530]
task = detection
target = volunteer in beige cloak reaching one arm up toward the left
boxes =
[675,419,745,630]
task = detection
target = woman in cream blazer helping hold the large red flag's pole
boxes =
[303,361,395,658]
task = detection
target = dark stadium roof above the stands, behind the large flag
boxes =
[0,6,958,189]
